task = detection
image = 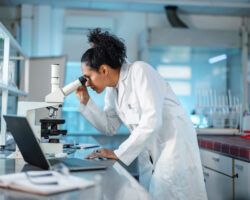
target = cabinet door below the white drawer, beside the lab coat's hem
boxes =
[203,167,233,200]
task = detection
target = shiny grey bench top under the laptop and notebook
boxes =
[0,150,152,200]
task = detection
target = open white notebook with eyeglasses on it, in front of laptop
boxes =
[0,171,94,195]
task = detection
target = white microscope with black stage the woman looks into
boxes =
[16,64,86,157]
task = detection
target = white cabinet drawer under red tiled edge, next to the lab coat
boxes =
[200,149,233,176]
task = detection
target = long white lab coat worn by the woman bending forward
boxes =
[80,61,207,200]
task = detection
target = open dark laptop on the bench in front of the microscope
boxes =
[3,115,107,171]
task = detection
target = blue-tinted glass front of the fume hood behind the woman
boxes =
[149,46,242,127]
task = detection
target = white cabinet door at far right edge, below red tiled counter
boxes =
[235,160,250,200]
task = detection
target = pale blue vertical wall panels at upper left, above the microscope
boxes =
[21,5,64,56]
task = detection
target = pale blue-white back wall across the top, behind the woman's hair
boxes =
[0,5,250,61]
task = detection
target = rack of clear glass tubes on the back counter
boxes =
[196,89,241,134]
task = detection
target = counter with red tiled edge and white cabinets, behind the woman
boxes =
[198,135,250,200]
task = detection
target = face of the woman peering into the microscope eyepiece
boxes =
[82,63,106,93]
